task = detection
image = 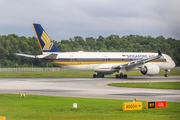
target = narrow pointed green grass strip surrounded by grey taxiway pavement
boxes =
[108,82,180,90]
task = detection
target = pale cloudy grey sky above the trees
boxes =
[0,0,180,41]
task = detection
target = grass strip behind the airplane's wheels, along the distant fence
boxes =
[0,69,180,78]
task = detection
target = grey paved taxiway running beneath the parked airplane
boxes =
[0,76,180,102]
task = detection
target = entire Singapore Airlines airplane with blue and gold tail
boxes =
[16,24,175,78]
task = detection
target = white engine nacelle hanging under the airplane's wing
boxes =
[141,64,160,76]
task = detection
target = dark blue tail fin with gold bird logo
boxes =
[32,23,60,52]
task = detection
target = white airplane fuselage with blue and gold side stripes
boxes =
[43,51,175,72]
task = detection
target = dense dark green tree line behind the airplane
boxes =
[0,34,180,67]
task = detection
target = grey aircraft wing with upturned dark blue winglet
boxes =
[112,49,162,69]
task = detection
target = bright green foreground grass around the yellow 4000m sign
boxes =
[0,94,180,120]
